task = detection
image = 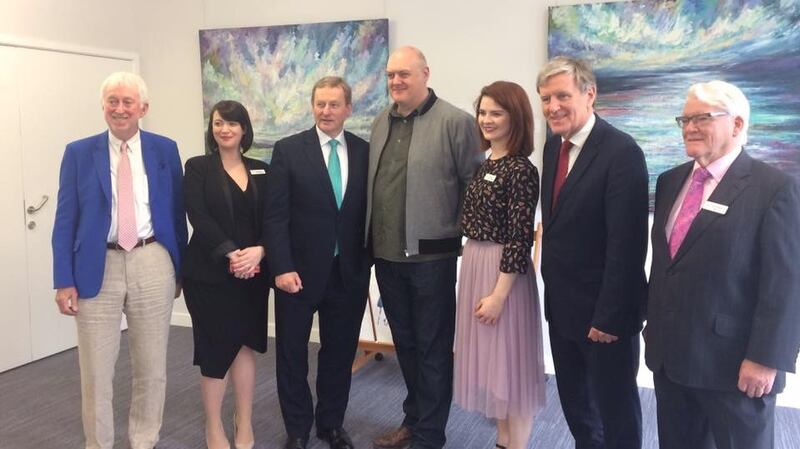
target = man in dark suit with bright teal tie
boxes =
[265,76,370,449]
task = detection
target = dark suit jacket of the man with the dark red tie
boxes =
[541,117,648,341]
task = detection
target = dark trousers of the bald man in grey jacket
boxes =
[375,257,456,449]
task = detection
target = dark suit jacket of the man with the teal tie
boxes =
[265,128,369,301]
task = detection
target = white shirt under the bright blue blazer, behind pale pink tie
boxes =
[107,131,153,243]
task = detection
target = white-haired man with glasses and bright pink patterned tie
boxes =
[645,81,800,449]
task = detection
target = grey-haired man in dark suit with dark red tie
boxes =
[537,57,647,449]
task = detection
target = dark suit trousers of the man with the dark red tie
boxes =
[550,327,642,449]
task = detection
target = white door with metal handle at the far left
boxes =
[0,41,136,371]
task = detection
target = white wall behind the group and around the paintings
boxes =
[6,0,800,407]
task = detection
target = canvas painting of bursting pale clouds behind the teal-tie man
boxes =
[200,19,389,162]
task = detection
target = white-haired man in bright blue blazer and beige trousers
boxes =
[53,72,187,449]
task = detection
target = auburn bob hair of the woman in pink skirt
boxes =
[475,81,533,157]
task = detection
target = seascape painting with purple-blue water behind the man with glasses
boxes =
[548,0,800,206]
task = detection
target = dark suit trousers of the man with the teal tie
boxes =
[275,257,367,438]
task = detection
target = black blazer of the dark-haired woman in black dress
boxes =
[182,153,269,282]
